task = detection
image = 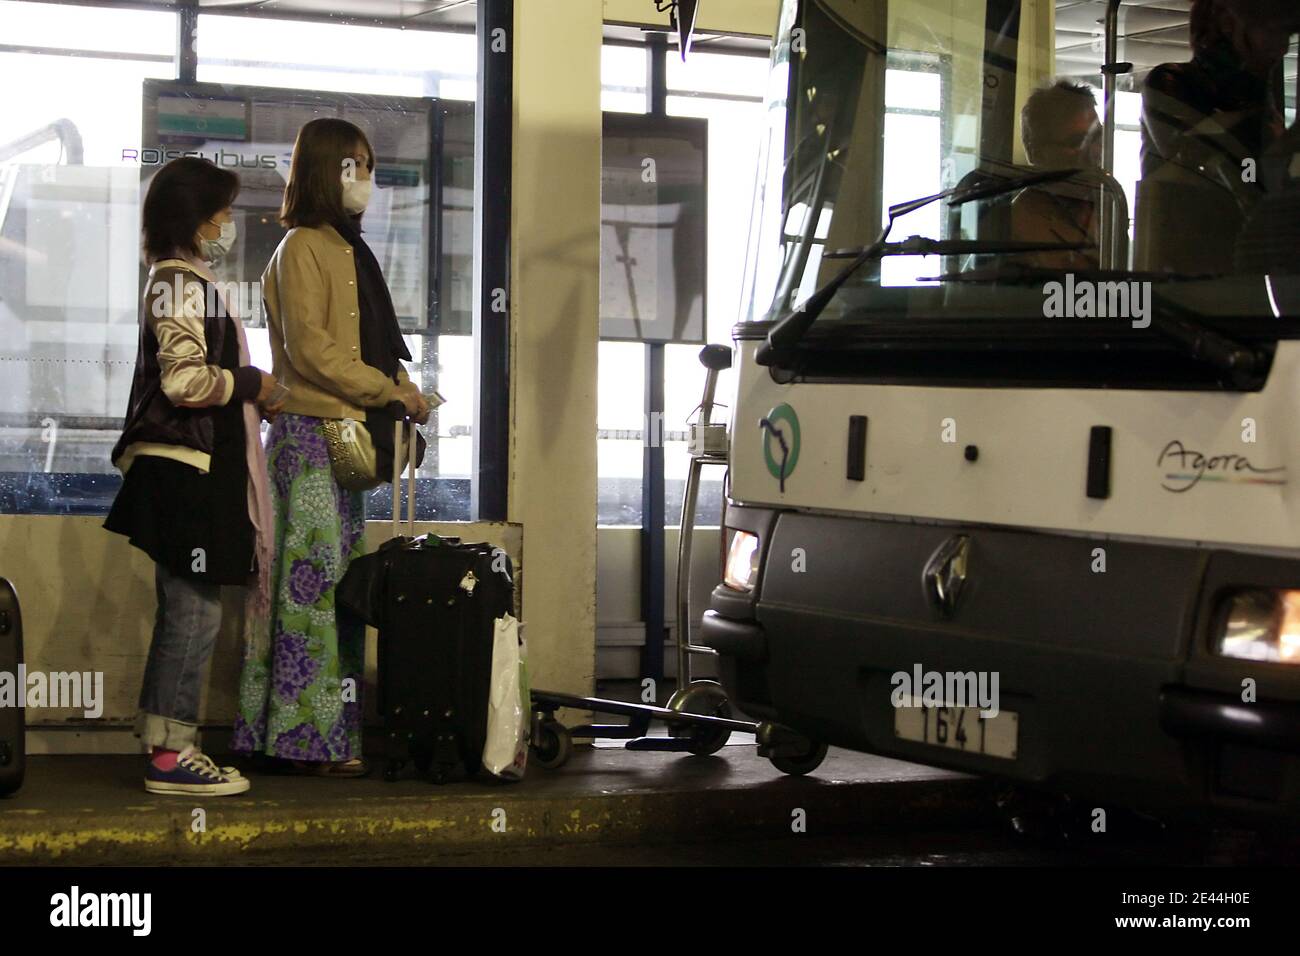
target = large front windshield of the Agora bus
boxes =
[741,0,1300,339]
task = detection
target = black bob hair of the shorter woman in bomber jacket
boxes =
[142,156,239,263]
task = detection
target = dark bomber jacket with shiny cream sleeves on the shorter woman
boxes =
[112,258,261,475]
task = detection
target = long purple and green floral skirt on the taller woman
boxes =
[234,414,365,761]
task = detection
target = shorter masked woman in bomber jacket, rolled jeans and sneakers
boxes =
[104,157,276,796]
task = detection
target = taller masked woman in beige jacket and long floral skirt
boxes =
[234,118,429,777]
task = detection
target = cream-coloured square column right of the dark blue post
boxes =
[510,0,602,693]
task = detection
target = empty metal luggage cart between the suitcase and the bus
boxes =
[529,345,826,775]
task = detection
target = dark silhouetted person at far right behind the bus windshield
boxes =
[1138,0,1295,274]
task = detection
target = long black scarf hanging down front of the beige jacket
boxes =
[334,216,425,479]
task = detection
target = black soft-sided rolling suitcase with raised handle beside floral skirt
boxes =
[337,421,515,783]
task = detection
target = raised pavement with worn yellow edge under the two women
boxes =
[0,744,993,866]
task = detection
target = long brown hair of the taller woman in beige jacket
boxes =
[280,116,374,229]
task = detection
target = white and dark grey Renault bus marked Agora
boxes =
[701,0,1300,819]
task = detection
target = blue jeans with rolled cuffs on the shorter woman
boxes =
[135,564,221,750]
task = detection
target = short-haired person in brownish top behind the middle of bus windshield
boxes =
[1011,79,1101,271]
